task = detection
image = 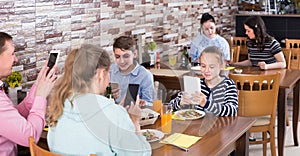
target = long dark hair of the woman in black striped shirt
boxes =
[244,16,273,51]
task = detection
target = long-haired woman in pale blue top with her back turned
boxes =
[47,44,151,156]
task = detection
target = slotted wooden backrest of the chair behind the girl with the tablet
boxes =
[229,73,280,119]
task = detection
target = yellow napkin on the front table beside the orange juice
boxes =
[160,133,202,148]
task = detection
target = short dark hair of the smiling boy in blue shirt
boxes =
[113,36,136,51]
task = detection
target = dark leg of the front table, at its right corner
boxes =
[235,131,249,156]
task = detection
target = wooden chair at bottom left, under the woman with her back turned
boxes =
[29,136,97,156]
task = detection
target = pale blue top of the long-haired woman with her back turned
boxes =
[47,94,151,156]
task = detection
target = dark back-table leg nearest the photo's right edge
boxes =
[293,81,299,146]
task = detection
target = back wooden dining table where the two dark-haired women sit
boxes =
[150,66,300,156]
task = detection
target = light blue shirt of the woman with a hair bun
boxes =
[189,34,230,62]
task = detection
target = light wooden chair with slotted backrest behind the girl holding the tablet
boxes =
[229,73,280,156]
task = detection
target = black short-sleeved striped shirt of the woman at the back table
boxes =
[247,39,282,66]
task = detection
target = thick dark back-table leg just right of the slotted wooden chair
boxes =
[277,88,286,156]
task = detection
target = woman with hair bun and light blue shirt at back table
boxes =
[189,13,230,65]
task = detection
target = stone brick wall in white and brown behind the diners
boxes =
[0,0,237,85]
